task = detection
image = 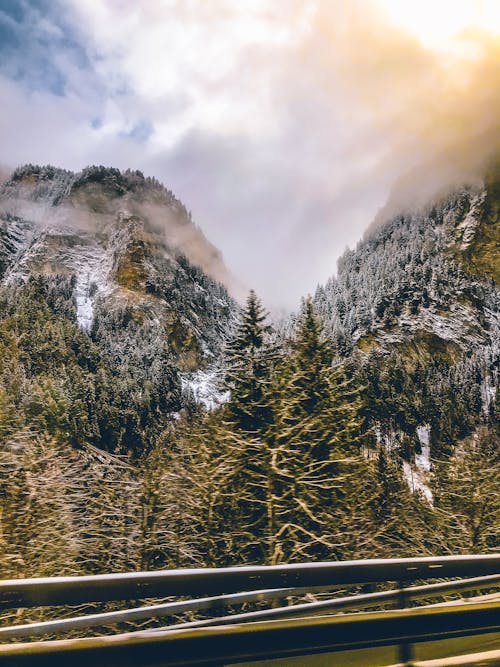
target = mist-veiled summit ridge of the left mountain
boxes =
[0,165,242,294]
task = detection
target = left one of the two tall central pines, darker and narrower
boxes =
[204,291,278,563]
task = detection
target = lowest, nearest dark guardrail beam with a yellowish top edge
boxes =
[0,602,500,667]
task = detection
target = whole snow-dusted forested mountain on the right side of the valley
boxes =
[314,160,500,495]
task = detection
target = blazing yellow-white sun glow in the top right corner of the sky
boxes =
[379,0,500,51]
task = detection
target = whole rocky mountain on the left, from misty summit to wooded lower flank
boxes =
[0,165,239,451]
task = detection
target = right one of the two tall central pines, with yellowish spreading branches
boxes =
[274,300,372,560]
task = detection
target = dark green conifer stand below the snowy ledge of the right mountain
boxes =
[355,349,495,461]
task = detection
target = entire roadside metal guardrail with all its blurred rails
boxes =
[0,554,500,667]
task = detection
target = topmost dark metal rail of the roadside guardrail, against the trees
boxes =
[0,554,500,609]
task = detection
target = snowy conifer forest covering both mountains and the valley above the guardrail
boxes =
[0,165,500,636]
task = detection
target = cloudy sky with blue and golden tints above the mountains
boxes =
[0,0,500,307]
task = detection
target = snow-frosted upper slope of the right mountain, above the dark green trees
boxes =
[315,173,500,356]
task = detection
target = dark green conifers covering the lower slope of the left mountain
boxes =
[0,276,180,455]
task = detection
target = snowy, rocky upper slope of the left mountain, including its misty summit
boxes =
[0,165,238,372]
